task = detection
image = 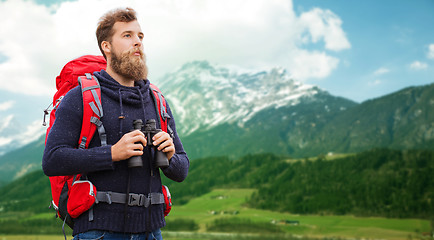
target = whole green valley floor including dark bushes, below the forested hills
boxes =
[0,188,430,240]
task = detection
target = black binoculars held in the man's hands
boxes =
[128,119,169,168]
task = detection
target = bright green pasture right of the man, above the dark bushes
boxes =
[167,189,430,239]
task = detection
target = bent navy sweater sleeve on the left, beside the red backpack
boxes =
[42,87,113,176]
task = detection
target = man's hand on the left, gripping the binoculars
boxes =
[111,130,147,162]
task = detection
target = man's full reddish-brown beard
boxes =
[110,48,148,81]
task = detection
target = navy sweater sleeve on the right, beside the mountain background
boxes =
[163,102,190,182]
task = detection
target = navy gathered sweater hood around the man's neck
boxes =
[94,70,151,105]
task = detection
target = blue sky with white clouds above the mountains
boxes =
[0,0,434,145]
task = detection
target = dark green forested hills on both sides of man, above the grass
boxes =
[0,149,434,219]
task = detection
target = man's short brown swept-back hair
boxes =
[96,8,137,59]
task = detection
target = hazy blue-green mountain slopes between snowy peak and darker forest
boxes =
[182,84,434,159]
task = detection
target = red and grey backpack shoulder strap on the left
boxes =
[78,73,107,149]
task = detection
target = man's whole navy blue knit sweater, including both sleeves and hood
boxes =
[42,70,189,235]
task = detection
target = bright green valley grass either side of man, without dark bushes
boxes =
[0,189,430,240]
